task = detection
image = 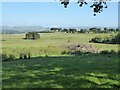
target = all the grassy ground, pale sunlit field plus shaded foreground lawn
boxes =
[2,33,120,88]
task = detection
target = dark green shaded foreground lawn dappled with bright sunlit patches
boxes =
[3,54,120,88]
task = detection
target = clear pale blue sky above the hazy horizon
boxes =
[0,2,118,27]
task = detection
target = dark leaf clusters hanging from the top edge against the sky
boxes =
[60,0,108,16]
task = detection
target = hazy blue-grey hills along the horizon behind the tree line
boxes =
[0,26,117,34]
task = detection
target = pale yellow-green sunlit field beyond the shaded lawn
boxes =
[2,33,118,57]
